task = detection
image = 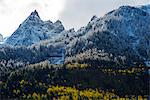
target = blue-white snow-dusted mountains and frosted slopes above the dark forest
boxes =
[0,5,150,66]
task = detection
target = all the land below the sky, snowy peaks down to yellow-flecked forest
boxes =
[0,5,150,100]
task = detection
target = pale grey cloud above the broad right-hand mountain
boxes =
[59,0,150,29]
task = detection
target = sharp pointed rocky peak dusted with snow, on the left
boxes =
[5,10,64,46]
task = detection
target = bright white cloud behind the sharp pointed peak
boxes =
[0,0,65,36]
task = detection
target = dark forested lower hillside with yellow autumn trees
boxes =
[0,62,149,100]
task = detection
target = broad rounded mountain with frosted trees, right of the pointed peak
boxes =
[66,6,150,66]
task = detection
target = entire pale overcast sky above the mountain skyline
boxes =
[0,0,150,36]
